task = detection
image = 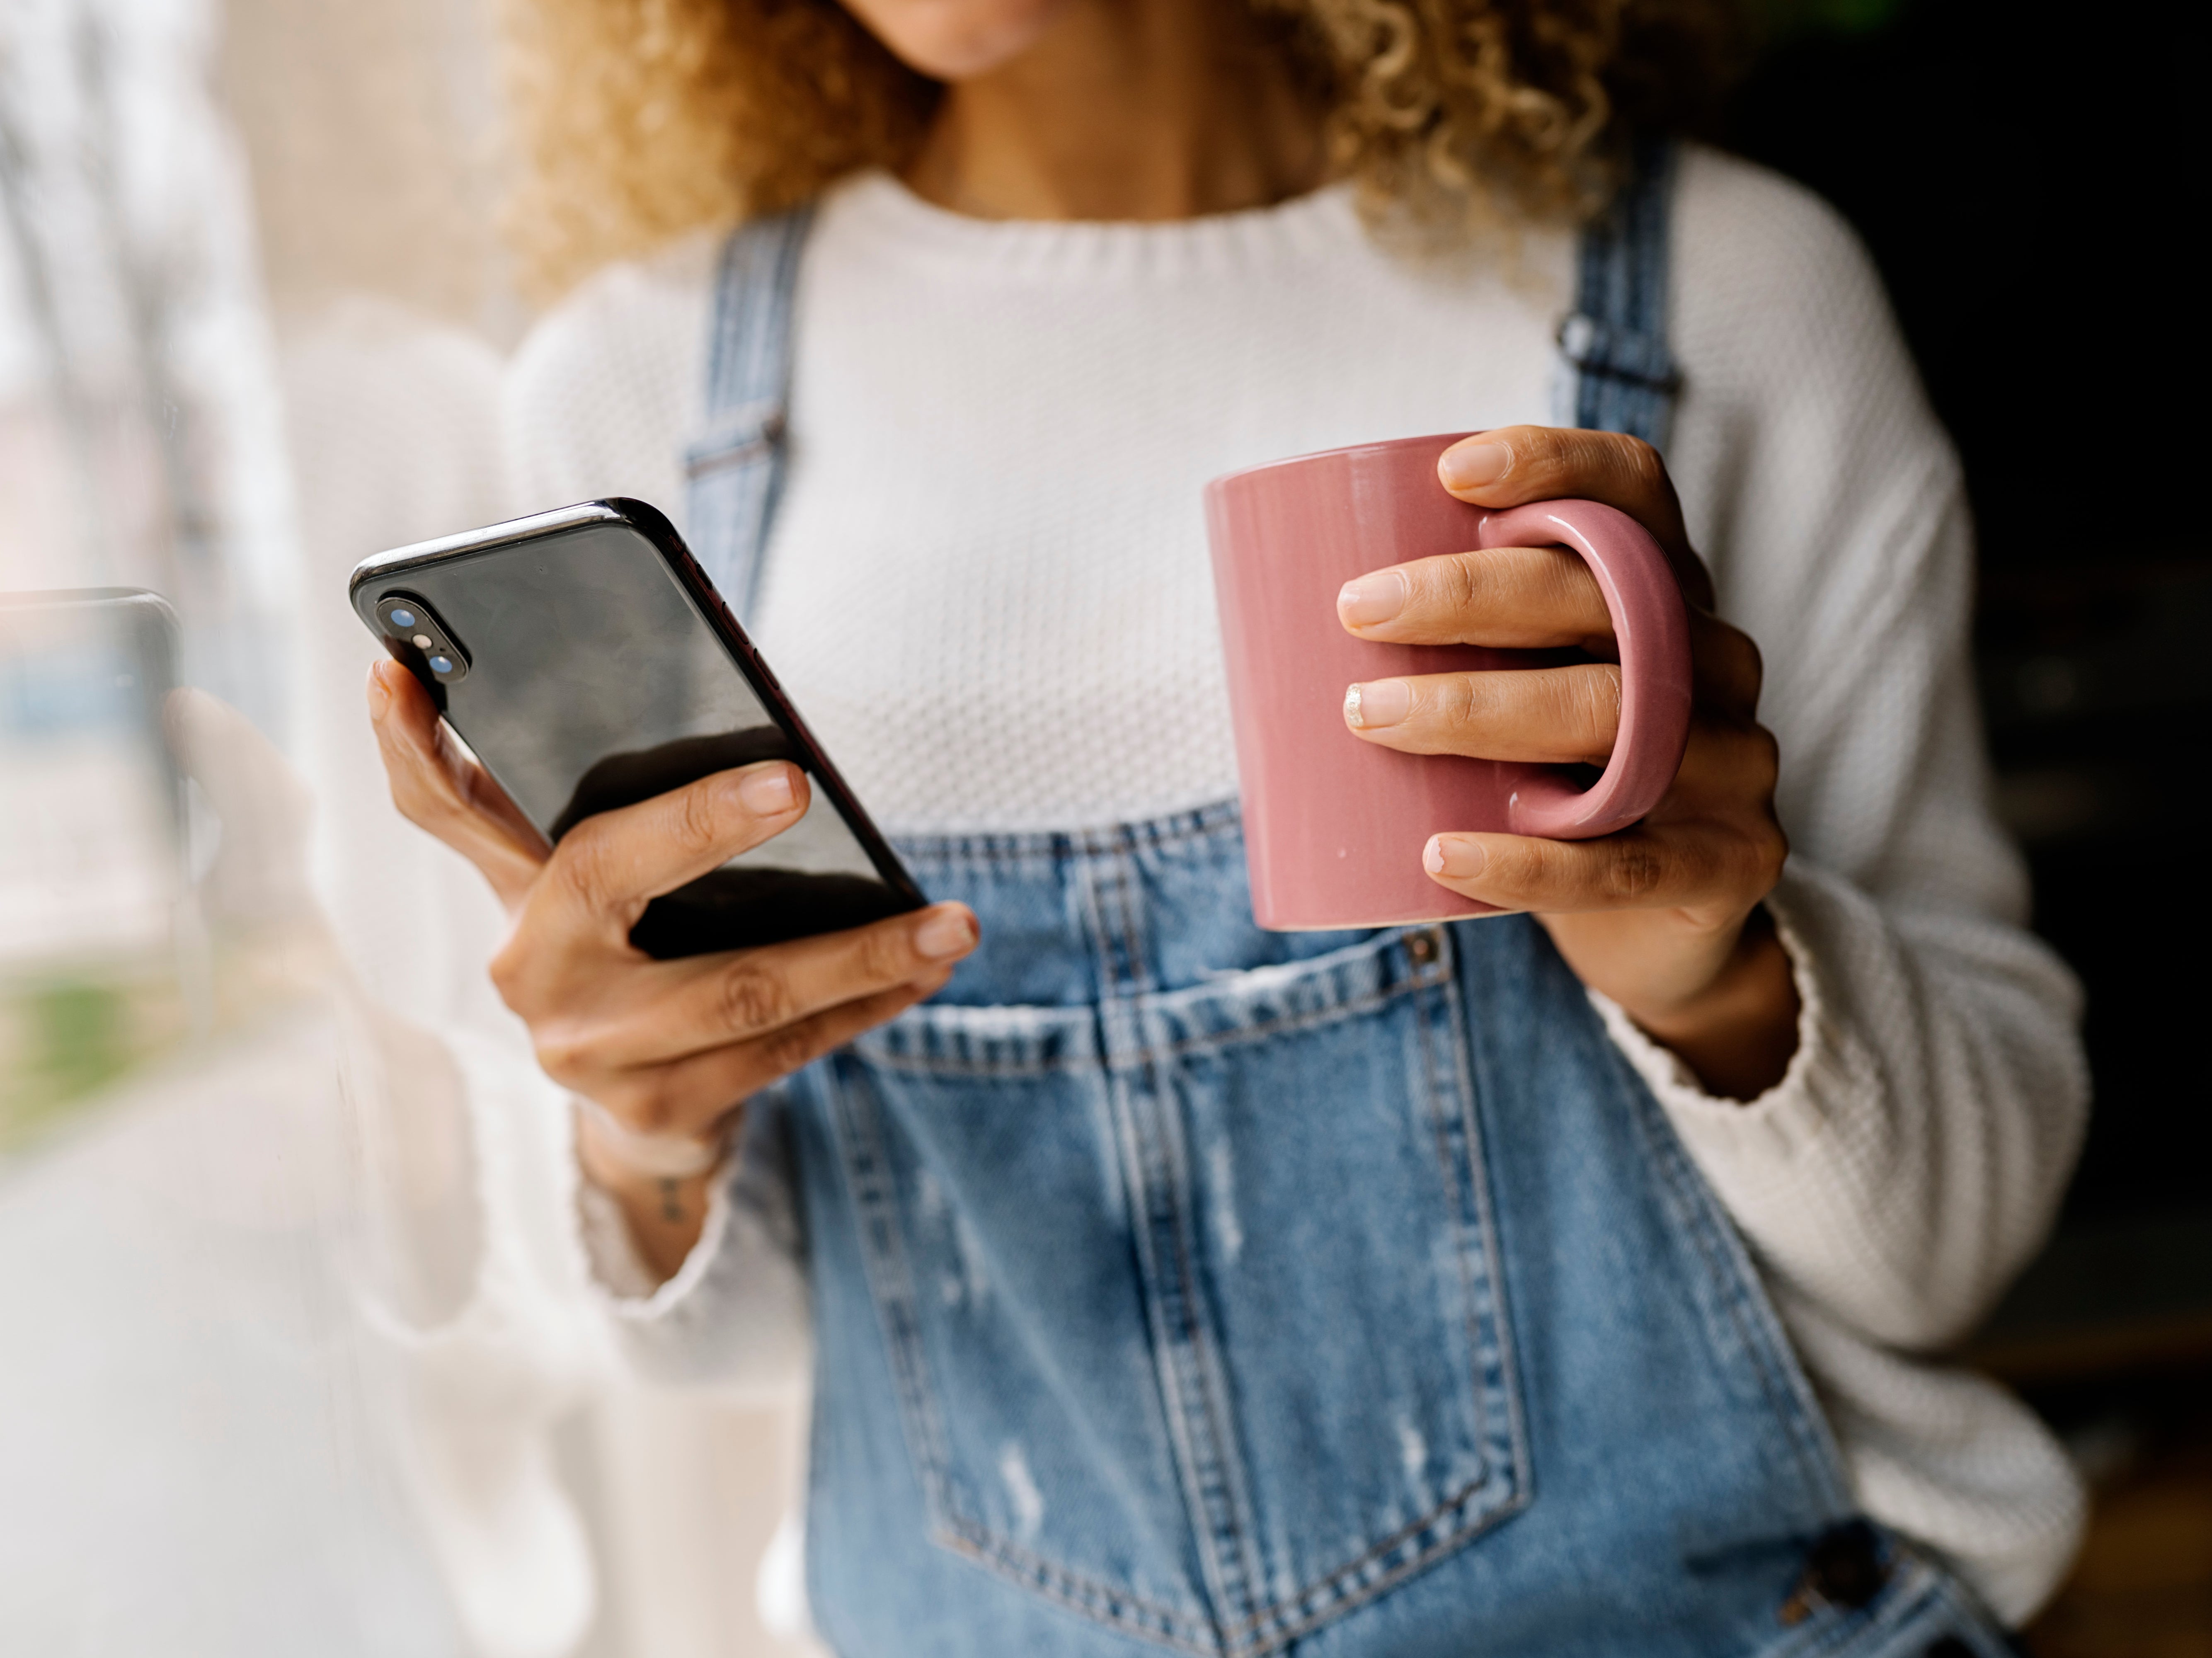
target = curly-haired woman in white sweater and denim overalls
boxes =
[369,0,2086,1658]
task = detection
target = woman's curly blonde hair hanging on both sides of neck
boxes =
[498,0,1737,297]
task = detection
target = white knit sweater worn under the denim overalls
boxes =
[506,150,2088,1620]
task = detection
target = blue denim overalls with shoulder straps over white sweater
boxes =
[690,146,2006,1658]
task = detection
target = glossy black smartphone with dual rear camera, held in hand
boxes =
[347,500,927,956]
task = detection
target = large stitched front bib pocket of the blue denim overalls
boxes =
[836,932,1529,1653]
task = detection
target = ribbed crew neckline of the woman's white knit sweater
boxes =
[823,168,1363,279]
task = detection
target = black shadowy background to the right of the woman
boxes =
[1721,0,2212,1658]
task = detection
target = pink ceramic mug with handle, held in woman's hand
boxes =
[1206,431,1690,932]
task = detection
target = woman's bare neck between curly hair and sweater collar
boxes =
[907,0,1323,219]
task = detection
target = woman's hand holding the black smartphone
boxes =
[367,662,976,1270]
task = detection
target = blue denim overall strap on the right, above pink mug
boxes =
[1555,137,1681,449]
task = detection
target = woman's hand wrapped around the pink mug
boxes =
[1336,425,1798,1100]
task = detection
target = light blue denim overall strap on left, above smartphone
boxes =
[683,208,814,620]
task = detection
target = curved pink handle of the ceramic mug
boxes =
[1475,500,1690,841]
